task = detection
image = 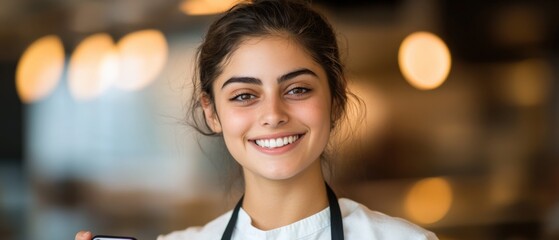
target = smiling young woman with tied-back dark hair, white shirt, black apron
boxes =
[76,0,437,240]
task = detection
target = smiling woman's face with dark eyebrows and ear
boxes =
[203,37,331,180]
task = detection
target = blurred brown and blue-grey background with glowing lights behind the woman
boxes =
[0,0,559,240]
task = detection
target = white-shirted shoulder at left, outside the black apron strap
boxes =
[157,211,232,240]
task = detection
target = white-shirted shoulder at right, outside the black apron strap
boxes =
[339,198,437,240]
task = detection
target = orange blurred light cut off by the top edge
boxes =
[180,0,239,15]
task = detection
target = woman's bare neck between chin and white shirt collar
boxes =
[243,161,328,230]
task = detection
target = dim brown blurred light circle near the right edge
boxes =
[503,59,553,106]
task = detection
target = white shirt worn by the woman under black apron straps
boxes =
[157,198,437,240]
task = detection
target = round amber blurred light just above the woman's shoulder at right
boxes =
[405,178,452,224]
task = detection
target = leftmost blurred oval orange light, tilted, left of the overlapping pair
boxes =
[16,35,64,103]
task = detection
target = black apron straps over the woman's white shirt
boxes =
[221,184,344,240]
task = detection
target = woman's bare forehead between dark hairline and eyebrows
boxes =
[217,35,326,81]
